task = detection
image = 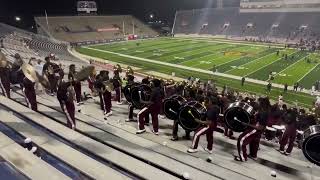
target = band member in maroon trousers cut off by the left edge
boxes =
[0,52,10,98]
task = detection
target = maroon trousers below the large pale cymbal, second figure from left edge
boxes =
[23,77,38,111]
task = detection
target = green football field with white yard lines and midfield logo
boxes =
[77,38,320,106]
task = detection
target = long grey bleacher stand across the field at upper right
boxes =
[174,8,320,40]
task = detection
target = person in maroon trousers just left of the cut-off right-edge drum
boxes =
[278,109,298,156]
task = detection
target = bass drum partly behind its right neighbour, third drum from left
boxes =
[163,95,187,120]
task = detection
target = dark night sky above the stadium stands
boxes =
[0,0,239,29]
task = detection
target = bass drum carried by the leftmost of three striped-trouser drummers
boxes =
[131,84,151,109]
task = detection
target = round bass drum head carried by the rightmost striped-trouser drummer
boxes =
[224,107,250,132]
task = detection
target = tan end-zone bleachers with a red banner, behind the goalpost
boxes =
[35,15,158,43]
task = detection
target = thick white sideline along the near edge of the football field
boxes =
[83,46,318,97]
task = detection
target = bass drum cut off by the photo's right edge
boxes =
[302,125,320,166]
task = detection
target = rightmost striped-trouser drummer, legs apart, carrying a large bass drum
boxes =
[234,98,270,161]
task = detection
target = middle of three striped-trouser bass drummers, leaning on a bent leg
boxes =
[187,97,220,154]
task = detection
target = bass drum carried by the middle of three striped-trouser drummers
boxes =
[179,101,207,131]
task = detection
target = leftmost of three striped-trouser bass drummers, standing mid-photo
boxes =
[136,79,162,135]
